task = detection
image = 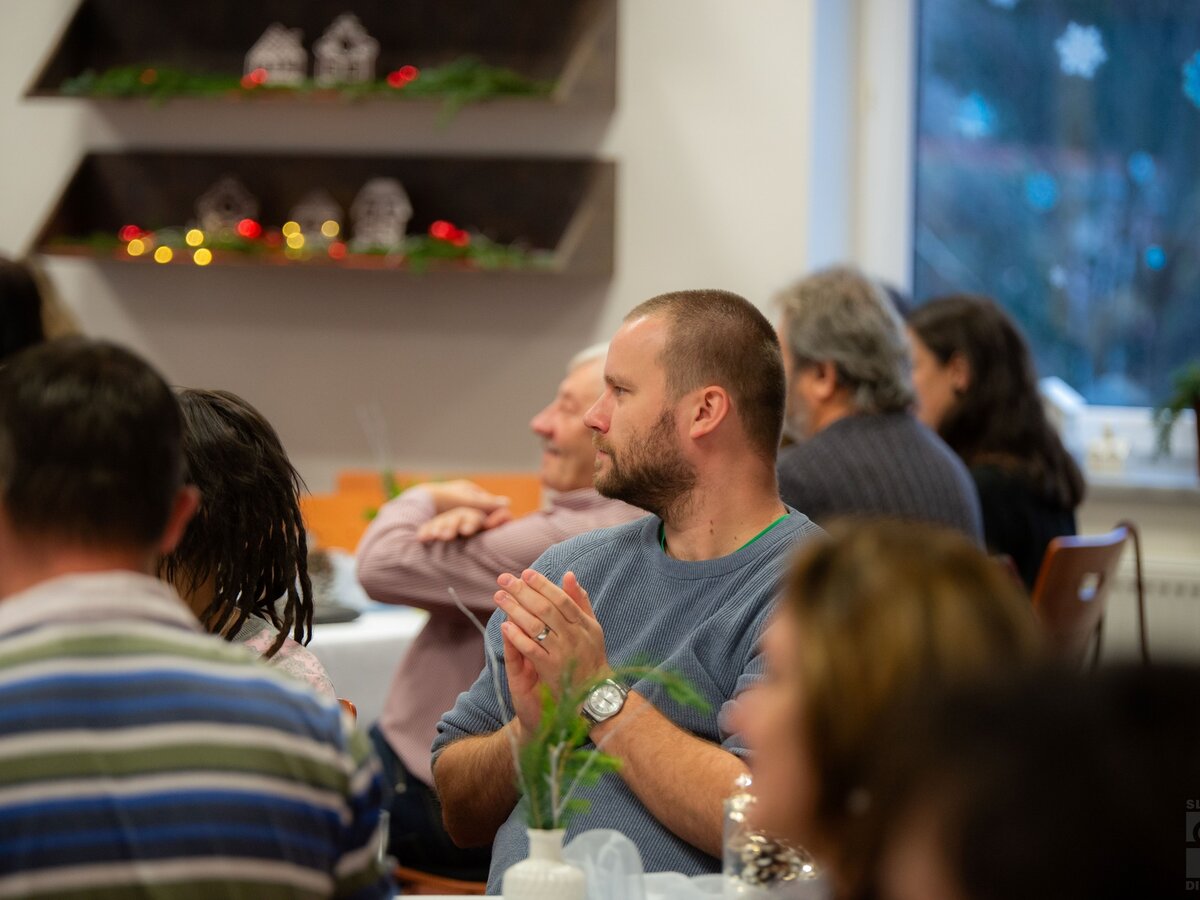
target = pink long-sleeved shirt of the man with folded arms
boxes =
[358,487,646,786]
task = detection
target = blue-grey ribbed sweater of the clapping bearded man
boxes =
[433,510,820,893]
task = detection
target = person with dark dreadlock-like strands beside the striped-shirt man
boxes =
[161,390,335,697]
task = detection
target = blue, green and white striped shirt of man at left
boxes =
[0,571,391,900]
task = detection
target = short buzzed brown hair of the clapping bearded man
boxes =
[625,289,786,464]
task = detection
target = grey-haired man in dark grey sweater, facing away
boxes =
[776,268,983,540]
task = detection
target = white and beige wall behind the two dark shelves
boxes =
[0,0,812,490]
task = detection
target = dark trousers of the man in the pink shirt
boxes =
[371,725,492,881]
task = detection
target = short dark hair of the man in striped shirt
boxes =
[0,337,184,548]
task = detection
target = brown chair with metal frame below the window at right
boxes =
[1033,522,1150,666]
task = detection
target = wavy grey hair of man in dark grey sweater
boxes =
[775,266,913,413]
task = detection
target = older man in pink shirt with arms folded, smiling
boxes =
[358,346,642,880]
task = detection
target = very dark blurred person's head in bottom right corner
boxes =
[863,666,1200,900]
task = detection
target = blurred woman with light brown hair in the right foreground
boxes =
[737,522,1040,898]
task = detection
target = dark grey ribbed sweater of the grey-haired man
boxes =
[779,413,983,544]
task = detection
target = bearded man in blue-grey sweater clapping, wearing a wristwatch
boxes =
[433,290,820,893]
